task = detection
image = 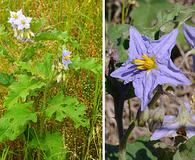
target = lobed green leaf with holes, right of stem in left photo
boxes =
[46,93,89,128]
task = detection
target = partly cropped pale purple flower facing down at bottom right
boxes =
[150,102,195,140]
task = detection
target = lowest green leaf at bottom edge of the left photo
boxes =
[28,132,67,160]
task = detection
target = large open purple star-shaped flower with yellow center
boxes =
[111,27,191,111]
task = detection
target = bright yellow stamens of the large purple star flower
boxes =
[132,54,157,71]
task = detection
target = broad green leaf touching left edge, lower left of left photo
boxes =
[0,103,37,142]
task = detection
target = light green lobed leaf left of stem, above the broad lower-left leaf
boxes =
[4,75,45,108]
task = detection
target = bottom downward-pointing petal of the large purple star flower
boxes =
[133,71,157,111]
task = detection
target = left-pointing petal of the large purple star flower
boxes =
[110,63,141,84]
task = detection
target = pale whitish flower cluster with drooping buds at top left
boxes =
[8,10,34,42]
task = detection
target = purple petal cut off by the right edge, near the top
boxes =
[183,23,195,47]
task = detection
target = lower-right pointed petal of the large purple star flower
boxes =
[157,59,191,86]
